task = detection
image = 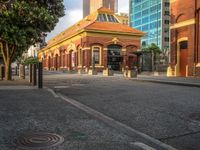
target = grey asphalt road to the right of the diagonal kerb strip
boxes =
[44,74,200,150]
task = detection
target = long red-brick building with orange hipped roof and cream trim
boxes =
[38,8,144,72]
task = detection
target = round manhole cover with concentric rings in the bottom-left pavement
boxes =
[16,133,64,149]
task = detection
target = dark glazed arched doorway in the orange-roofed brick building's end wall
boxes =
[108,44,123,71]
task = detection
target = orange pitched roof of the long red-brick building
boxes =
[48,7,144,46]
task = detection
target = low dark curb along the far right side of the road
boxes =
[130,78,200,88]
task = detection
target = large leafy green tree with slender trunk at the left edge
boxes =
[0,0,64,80]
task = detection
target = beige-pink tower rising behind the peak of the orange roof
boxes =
[83,0,118,17]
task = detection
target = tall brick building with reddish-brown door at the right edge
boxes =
[168,0,200,77]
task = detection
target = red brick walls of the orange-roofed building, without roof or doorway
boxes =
[39,35,140,71]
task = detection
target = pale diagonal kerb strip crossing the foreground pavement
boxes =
[54,92,177,150]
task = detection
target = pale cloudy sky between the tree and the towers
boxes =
[46,0,129,41]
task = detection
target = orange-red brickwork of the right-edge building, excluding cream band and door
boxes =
[171,0,200,76]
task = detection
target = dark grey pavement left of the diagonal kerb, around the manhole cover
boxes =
[0,89,144,150]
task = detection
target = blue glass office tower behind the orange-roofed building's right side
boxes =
[129,0,170,50]
